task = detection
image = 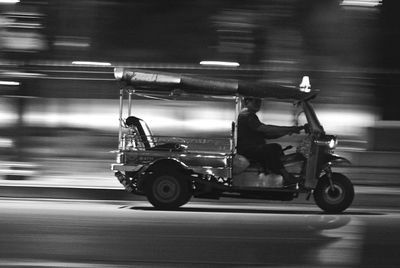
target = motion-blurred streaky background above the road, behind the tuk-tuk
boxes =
[0,0,400,186]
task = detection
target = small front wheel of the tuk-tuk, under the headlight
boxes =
[314,173,354,213]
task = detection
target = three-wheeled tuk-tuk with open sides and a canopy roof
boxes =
[111,68,354,213]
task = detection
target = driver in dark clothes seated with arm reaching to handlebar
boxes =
[237,97,302,187]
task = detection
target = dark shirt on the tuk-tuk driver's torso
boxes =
[237,110,265,156]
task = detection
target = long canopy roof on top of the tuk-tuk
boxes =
[114,68,315,100]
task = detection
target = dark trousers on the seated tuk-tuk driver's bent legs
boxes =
[238,143,284,174]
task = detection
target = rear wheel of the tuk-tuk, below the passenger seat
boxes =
[145,172,192,210]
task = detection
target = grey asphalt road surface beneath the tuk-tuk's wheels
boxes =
[0,198,400,267]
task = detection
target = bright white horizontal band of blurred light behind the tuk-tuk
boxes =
[17,98,378,147]
